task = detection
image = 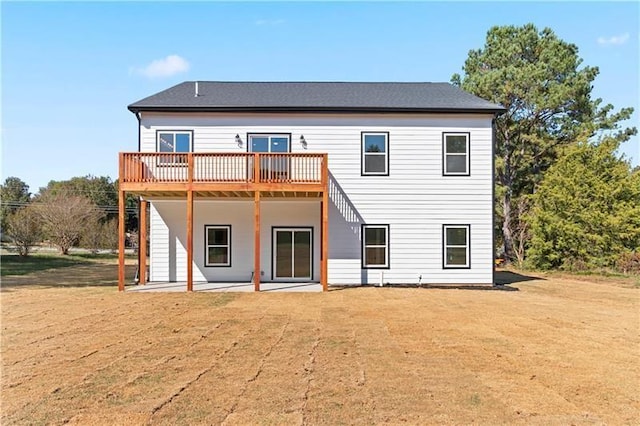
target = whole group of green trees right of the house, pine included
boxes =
[451,24,640,272]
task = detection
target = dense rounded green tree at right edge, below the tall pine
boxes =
[528,139,640,269]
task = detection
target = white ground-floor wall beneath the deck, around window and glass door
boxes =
[150,200,320,282]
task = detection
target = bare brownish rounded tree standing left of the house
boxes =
[34,191,104,254]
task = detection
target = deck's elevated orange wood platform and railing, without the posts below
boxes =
[119,152,327,198]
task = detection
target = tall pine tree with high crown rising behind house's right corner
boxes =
[451,24,636,259]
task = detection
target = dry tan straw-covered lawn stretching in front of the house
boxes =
[0,265,640,425]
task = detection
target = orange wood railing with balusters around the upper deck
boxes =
[120,152,327,184]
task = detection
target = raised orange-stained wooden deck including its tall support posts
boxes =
[118,152,329,291]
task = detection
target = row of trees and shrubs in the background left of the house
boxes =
[0,176,138,256]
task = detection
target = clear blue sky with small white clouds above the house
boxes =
[0,2,640,192]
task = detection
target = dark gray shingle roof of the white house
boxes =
[129,81,504,113]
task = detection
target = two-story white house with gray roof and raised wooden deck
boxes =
[119,81,504,290]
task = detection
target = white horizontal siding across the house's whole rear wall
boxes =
[141,113,493,284]
